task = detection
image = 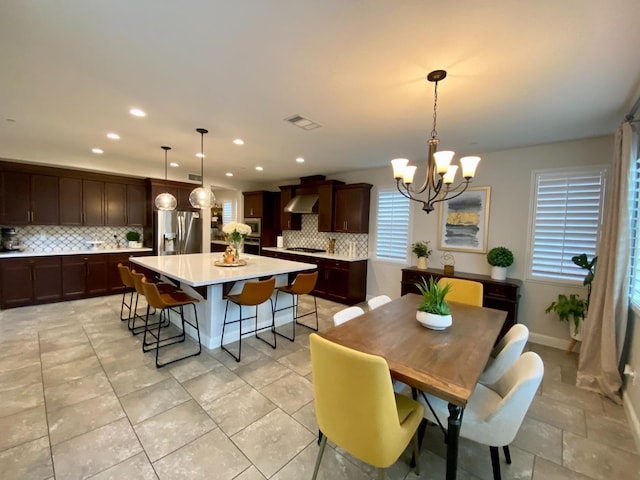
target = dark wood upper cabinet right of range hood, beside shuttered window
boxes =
[333,183,372,233]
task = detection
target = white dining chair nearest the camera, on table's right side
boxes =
[419,352,544,480]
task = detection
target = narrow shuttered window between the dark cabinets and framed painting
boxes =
[376,187,410,262]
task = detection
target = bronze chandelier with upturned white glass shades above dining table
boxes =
[391,70,480,213]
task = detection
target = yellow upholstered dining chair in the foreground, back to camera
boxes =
[309,333,424,480]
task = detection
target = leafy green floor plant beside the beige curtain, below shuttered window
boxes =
[545,253,598,351]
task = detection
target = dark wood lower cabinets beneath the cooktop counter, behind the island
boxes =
[262,250,367,305]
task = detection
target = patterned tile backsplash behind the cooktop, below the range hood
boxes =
[282,214,369,257]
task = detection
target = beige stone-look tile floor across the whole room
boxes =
[0,296,640,480]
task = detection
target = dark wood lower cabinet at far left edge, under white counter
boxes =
[0,256,62,309]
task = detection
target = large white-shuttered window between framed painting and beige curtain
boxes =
[529,166,607,283]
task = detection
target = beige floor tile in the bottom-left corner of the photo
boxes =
[0,437,53,480]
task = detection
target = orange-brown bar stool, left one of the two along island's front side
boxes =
[220,277,276,362]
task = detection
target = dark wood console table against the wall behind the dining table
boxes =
[401,267,522,338]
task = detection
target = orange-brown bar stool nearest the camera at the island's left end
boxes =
[141,276,202,368]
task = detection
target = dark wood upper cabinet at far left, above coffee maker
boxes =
[0,171,59,225]
